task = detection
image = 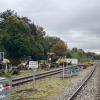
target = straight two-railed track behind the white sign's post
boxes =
[12,66,74,87]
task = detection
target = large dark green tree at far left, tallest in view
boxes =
[0,10,34,59]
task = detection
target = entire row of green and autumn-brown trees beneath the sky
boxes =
[0,10,100,62]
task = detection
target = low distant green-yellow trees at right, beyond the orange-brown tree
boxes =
[66,48,100,62]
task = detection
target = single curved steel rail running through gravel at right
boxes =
[67,66,96,100]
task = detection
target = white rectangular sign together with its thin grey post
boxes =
[29,61,38,90]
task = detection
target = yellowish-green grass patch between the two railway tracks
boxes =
[12,76,77,100]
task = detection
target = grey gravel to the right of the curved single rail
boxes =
[75,63,100,100]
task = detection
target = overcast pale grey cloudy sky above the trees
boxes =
[0,0,100,52]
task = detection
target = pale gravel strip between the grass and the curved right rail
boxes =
[52,66,93,100]
